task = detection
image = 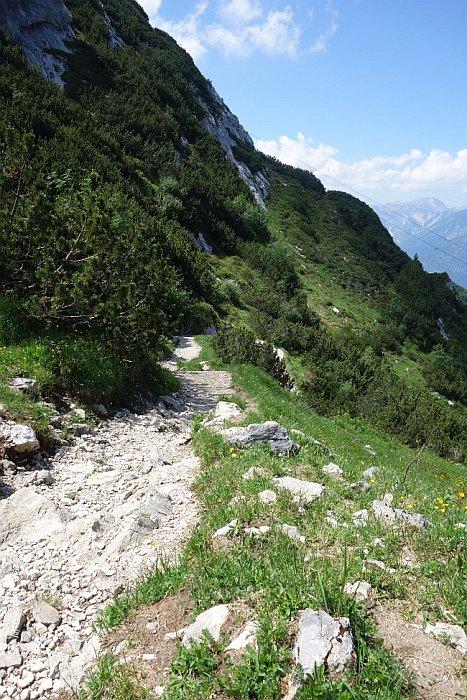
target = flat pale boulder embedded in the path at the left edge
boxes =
[0,487,64,544]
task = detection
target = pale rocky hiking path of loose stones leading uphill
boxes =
[0,338,232,700]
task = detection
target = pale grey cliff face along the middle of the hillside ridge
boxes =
[197,81,270,206]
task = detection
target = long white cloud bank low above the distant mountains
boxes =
[255,133,467,198]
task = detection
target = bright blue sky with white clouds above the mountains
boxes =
[139,0,467,207]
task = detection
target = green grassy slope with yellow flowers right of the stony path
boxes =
[83,338,467,700]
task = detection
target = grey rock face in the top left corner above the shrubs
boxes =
[0,0,75,85]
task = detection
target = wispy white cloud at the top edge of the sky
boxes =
[140,0,330,60]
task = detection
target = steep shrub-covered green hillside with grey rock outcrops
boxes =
[0,0,467,459]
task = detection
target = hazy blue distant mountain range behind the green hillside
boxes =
[374,197,467,288]
